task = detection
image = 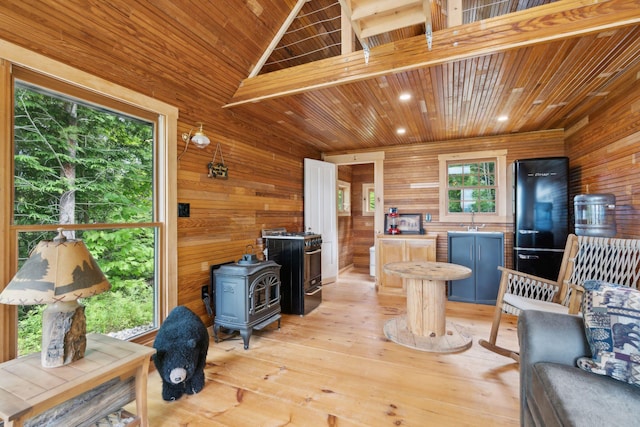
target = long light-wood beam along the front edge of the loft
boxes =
[225,0,640,107]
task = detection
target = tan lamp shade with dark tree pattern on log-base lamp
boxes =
[0,231,111,305]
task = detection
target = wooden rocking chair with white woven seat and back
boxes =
[478,234,640,361]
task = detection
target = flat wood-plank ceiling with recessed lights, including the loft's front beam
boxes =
[227,0,640,152]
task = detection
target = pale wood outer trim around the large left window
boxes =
[0,39,178,361]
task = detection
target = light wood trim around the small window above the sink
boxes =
[438,150,510,223]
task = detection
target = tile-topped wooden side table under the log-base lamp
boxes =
[0,334,155,427]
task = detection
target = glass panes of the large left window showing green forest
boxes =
[13,78,158,354]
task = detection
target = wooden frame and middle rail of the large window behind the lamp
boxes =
[0,40,178,361]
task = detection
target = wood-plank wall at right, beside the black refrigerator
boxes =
[566,69,640,238]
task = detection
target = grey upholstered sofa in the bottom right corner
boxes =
[518,310,640,427]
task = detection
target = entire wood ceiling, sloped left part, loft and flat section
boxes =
[0,0,640,152]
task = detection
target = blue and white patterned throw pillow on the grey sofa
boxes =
[577,280,640,387]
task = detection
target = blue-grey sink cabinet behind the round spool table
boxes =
[447,232,504,305]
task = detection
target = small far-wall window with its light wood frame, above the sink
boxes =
[438,151,508,223]
